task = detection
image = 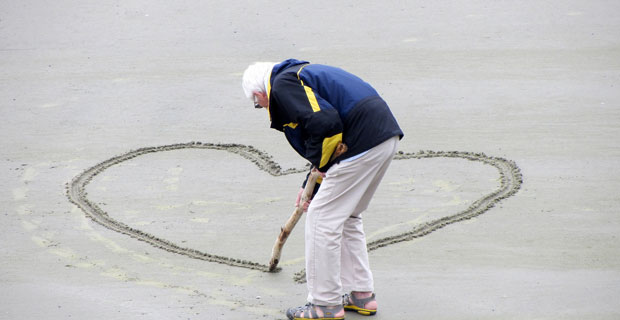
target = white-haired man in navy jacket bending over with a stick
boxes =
[243,59,403,319]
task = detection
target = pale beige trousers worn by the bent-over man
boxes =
[305,136,399,305]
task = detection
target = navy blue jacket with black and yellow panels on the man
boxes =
[267,59,403,172]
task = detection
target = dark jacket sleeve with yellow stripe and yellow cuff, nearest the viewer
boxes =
[272,77,343,172]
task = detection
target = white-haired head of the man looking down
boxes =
[242,62,275,108]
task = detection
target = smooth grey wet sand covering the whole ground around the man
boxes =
[0,1,620,319]
